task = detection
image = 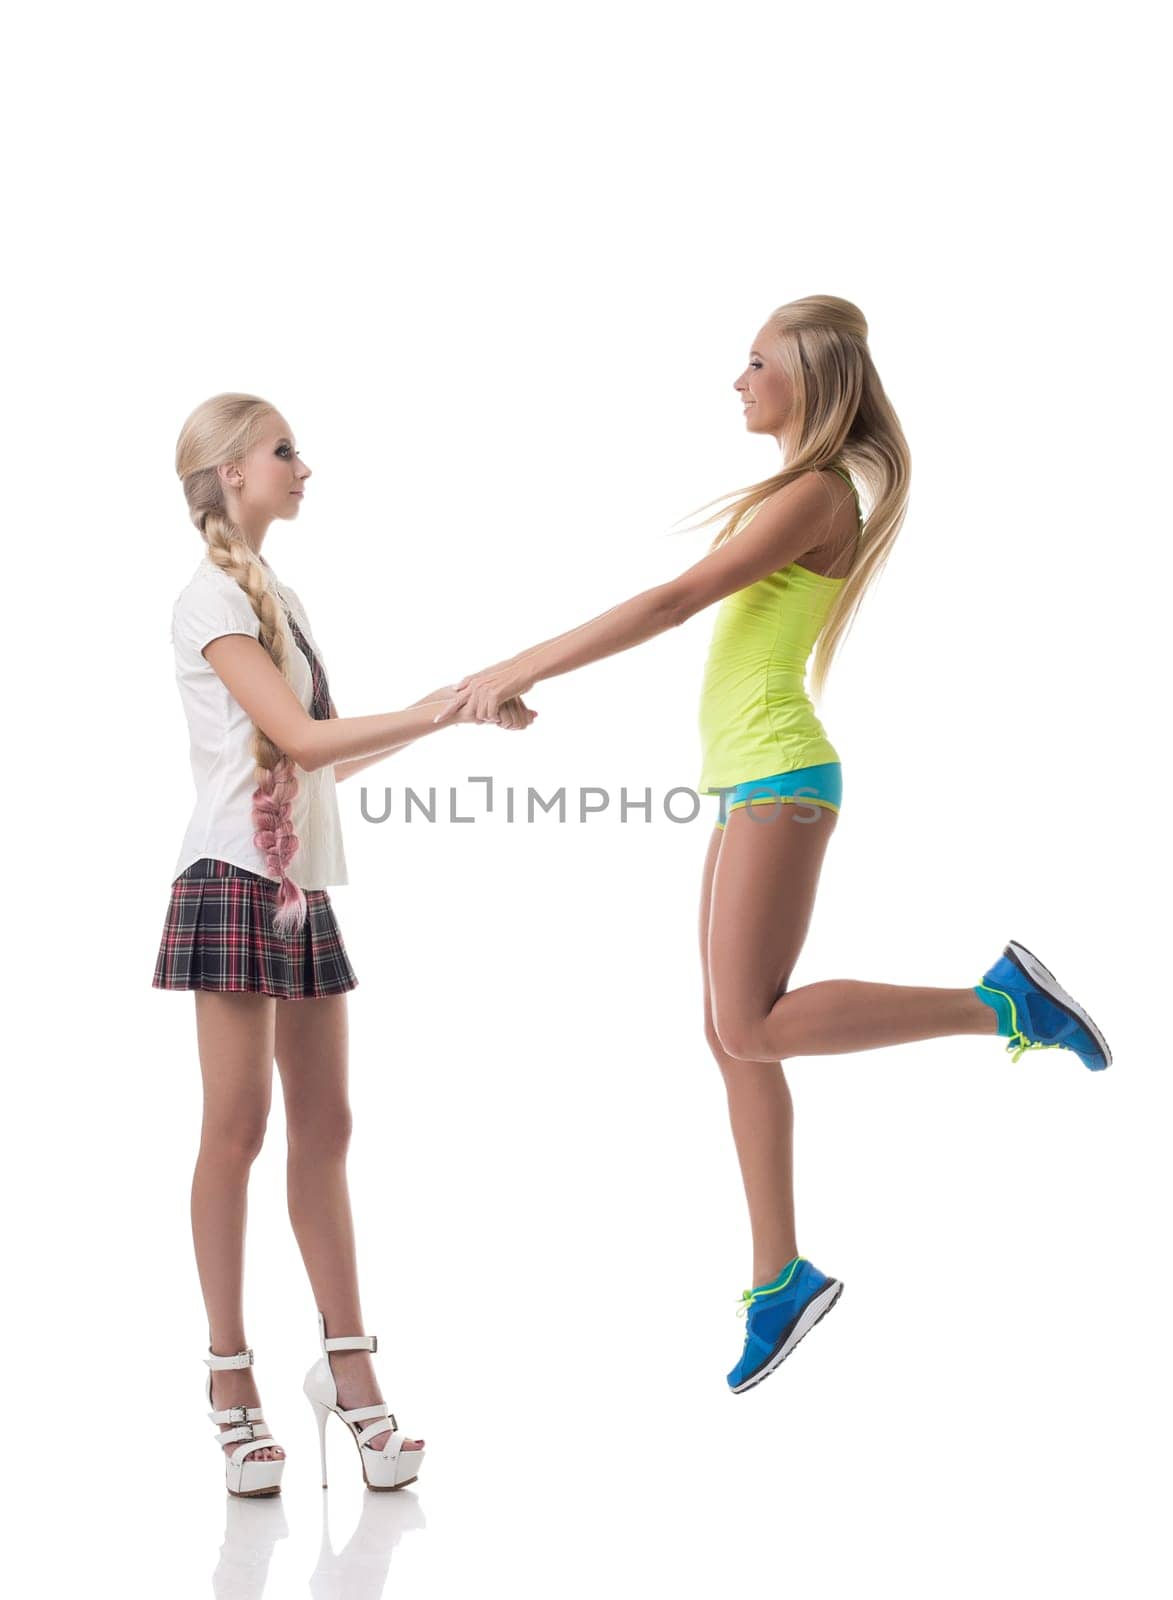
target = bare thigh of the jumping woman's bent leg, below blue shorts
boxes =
[707,803,839,1056]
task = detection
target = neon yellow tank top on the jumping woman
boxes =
[698,467,863,794]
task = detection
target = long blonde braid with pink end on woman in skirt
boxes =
[174,394,306,936]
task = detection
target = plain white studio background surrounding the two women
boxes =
[3,0,1173,1600]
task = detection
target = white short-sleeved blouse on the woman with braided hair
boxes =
[171,557,349,890]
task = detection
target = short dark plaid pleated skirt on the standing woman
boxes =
[152,856,358,1000]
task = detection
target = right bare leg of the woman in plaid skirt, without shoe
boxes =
[277,994,424,1450]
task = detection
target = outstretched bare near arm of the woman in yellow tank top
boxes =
[435,472,834,723]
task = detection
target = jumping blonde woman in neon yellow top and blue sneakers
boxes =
[440,294,1111,1394]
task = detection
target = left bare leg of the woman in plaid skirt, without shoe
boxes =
[192,989,285,1461]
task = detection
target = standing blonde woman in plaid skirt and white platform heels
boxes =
[154,394,536,1496]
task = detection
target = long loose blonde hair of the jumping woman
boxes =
[693,294,912,694]
